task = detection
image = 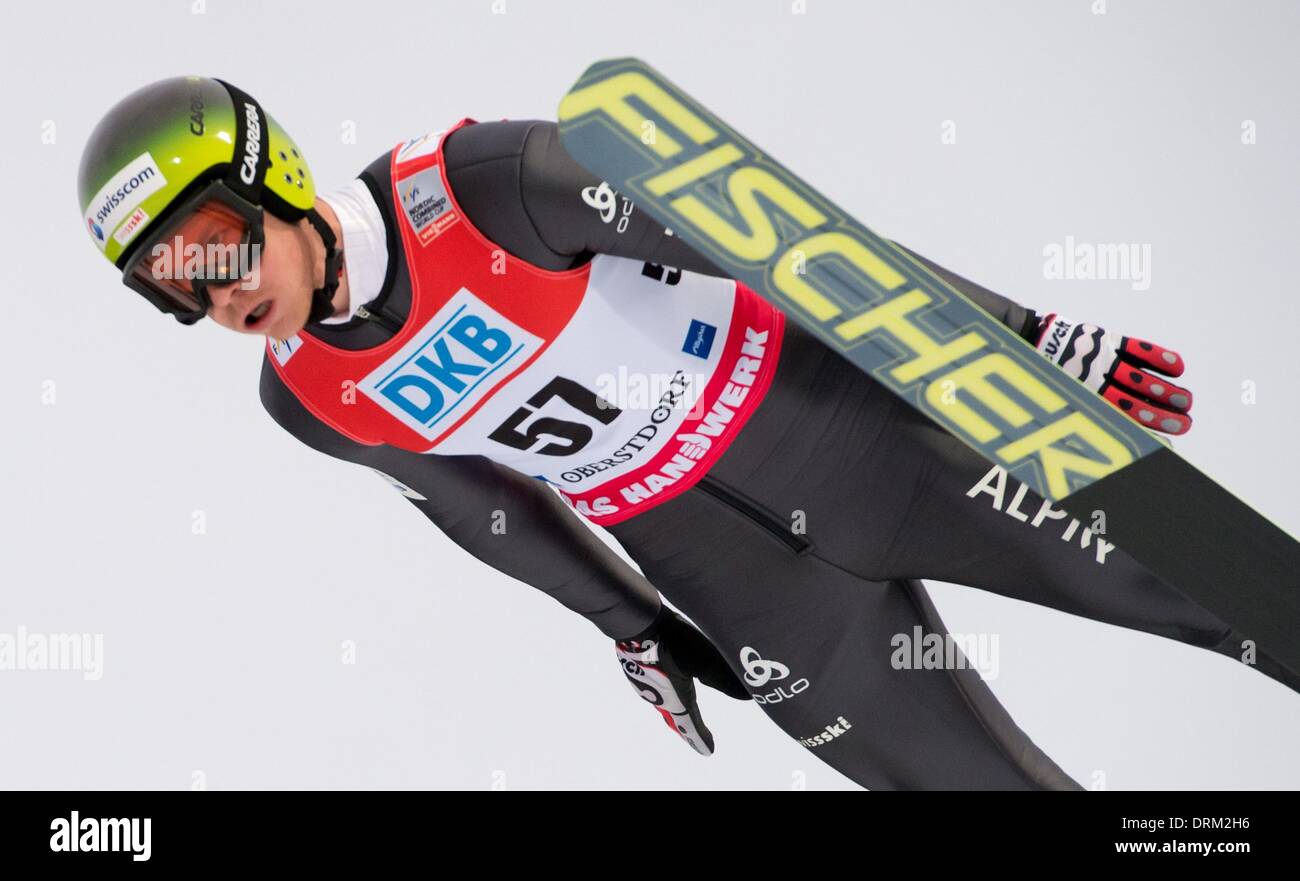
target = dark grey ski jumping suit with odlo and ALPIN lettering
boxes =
[261,121,1296,789]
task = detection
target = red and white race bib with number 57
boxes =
[268,120,784,524]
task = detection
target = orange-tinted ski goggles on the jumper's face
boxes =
[122,181,267,325]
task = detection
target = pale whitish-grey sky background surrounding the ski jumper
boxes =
[0,0,1300,789]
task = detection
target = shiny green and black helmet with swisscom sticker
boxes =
[77,77,339,324]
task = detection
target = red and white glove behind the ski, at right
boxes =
[1035,312,1192,434]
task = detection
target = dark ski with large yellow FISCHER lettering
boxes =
[559,58,1300,674]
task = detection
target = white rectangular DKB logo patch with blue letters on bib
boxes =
[358,287,542,441]
